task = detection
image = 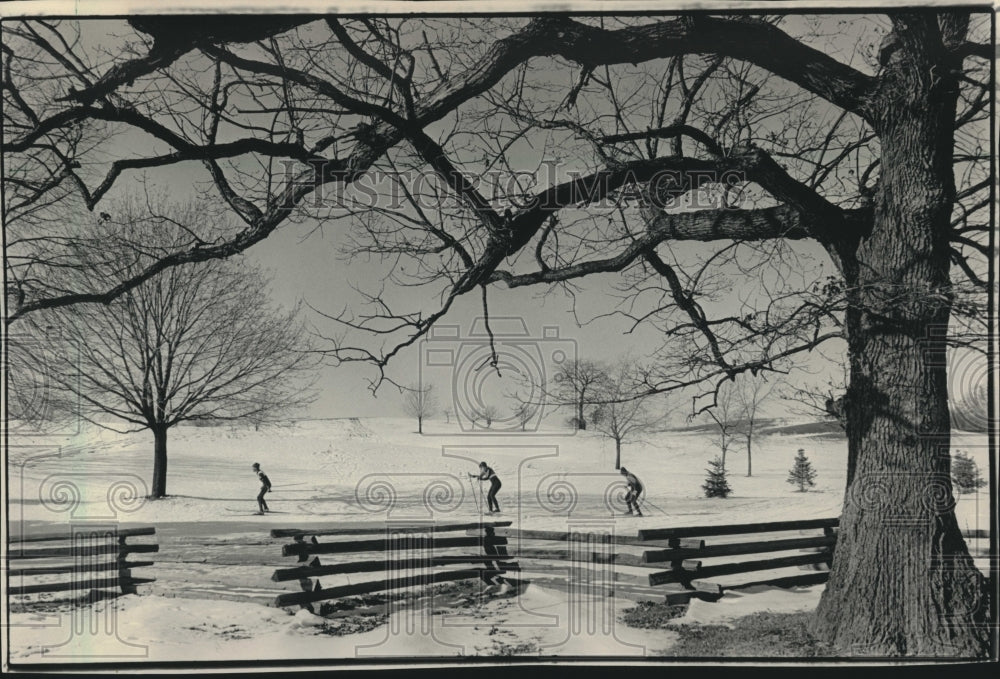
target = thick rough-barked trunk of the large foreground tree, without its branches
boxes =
[815,21,988,657]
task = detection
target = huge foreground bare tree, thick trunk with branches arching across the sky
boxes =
[3,8,996,656]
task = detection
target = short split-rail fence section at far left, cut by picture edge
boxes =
[6,527,160,597]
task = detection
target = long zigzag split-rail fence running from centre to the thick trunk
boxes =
[271,518,992,609]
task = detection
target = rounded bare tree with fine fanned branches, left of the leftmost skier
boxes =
[11,203,317,498]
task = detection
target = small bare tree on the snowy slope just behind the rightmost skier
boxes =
[591,359,669,469]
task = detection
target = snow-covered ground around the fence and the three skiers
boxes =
[6,418,989,663]
